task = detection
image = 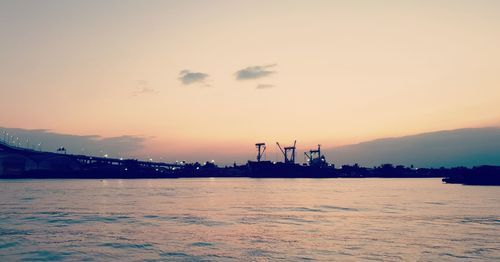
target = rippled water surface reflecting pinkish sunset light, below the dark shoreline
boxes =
[0,178,500,261]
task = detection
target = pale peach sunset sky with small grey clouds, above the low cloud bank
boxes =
[0,0,500,162]
